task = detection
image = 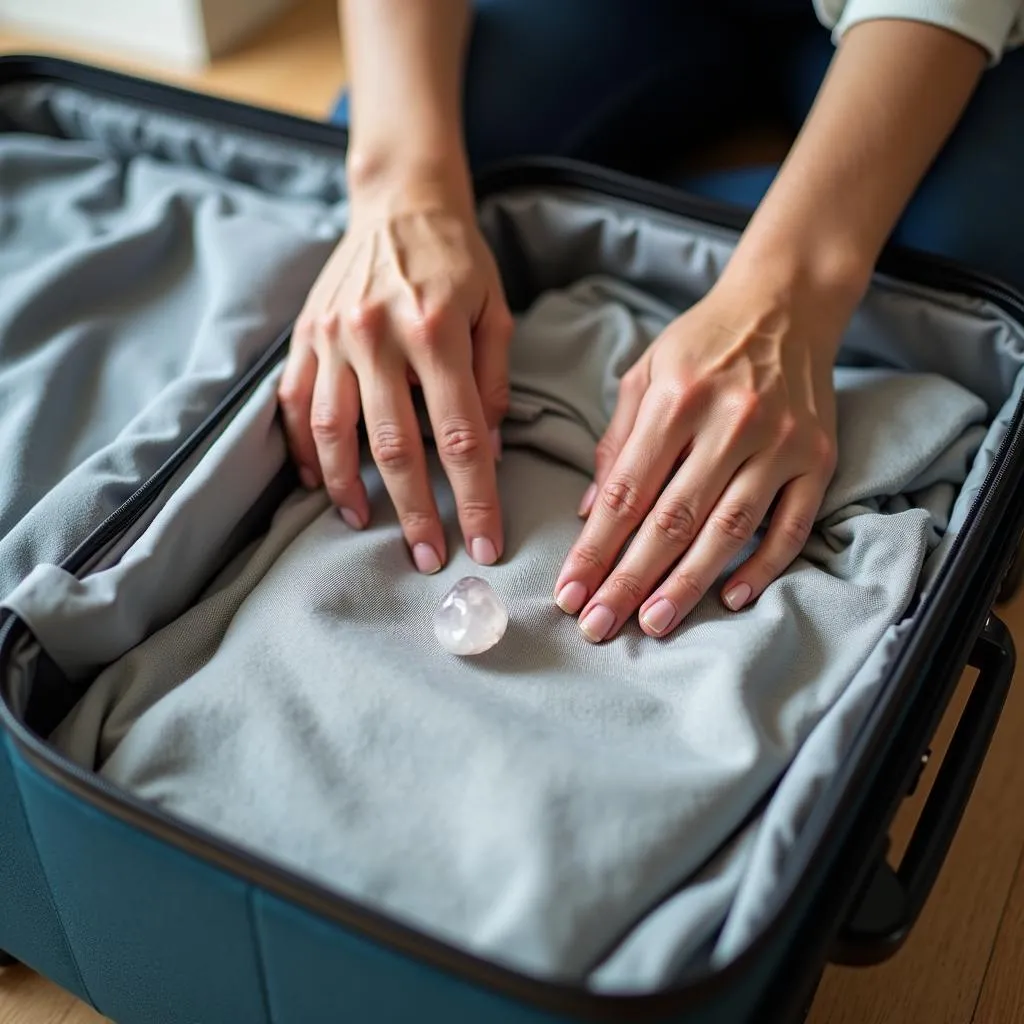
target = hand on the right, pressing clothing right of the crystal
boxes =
[555,271,845,643]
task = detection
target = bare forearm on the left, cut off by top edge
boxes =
[340,0,469,207]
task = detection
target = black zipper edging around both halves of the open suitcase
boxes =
[0,64,1024,1021]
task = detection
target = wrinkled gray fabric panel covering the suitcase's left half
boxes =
[0,86,346,597]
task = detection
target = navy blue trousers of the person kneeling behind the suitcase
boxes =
[334,0,1024,288]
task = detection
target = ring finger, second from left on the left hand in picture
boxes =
[309,313,370,529]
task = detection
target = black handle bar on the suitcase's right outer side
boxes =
[829,614,1016,966]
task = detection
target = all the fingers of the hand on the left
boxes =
[296,292,508,572]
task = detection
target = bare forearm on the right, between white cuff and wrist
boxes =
[733,20,985,327]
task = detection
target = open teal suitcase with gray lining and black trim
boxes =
[0,58,1024,1024]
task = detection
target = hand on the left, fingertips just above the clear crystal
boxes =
[279,177,512,572]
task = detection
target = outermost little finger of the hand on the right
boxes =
[722,474,828,611]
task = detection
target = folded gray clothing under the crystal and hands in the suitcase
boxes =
[52,279,986,980]
